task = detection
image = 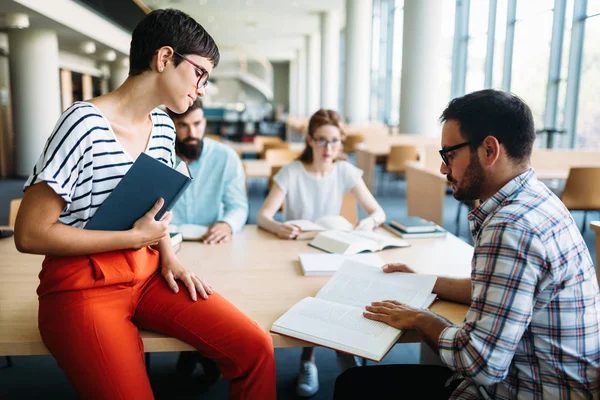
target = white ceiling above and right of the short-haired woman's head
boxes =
[143,0,345,61]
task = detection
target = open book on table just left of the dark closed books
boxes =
[308,231,410,254]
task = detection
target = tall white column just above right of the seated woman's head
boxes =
[344,0,372,124]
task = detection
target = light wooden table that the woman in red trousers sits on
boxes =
[0,225,473,355]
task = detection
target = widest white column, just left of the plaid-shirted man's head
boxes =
[399,0,448,136]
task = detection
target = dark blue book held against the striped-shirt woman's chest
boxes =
[85,153,192,231]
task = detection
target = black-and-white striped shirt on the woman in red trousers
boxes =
[23,102,175,228]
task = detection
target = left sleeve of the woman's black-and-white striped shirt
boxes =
[23,103,102,208]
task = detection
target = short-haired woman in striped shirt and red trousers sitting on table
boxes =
[15,9,275,400]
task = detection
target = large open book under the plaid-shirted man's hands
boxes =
[271,260,436,362]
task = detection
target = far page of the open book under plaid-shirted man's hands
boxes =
[316,260,437,312]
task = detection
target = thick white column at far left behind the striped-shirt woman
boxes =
[8,29,61,177]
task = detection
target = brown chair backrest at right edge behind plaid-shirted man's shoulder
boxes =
[561,167,600,210]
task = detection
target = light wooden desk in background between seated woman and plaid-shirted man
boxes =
[356,134,440,193]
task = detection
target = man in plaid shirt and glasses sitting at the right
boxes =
[335,90,600,399]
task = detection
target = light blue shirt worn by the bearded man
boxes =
[172,138,248,232]
